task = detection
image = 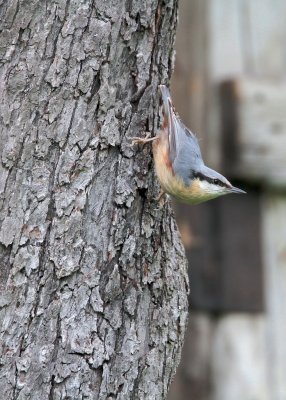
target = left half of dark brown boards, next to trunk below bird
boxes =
[176,203,223,312]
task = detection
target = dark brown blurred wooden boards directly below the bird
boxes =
[177,190,264,312]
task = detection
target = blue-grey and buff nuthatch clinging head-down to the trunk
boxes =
[132,85,246,205]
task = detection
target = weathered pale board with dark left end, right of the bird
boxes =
[221,78,286,186]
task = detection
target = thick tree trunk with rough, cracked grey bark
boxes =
[0,0,190,400]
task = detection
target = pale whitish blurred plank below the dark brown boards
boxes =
[210,314,270,400]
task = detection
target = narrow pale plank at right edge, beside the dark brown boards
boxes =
[263,193,286,400]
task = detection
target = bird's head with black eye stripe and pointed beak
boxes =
[188,165,246,204]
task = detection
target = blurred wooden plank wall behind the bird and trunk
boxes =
[168,0,286,400]
